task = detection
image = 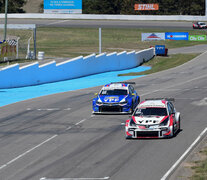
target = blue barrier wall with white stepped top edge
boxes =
[0,48,154,89]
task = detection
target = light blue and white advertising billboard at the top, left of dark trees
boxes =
[44,0,82,14]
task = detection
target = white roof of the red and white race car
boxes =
[138,100,168,108]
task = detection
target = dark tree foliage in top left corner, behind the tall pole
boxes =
[0,0,25,13]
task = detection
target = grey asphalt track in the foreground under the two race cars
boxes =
[0,48,207,180]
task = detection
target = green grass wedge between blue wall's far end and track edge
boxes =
[119,54,199,76]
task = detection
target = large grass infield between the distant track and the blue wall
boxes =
[34,27,206,58]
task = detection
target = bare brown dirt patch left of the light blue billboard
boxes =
[23,0,43,13]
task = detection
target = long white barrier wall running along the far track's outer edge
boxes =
[0,13,207,21]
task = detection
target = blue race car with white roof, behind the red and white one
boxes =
[93,82,140,114]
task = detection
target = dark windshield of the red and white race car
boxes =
[134,108,167,116]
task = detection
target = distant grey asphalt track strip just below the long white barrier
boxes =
[0,19,196,31]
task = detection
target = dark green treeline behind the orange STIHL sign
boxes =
[83,0,205,15]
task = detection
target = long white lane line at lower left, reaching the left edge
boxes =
[0,134,58,170]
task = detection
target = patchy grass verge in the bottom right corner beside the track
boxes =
[190,148,207,180]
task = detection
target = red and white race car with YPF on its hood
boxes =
[125,98,180,139]
